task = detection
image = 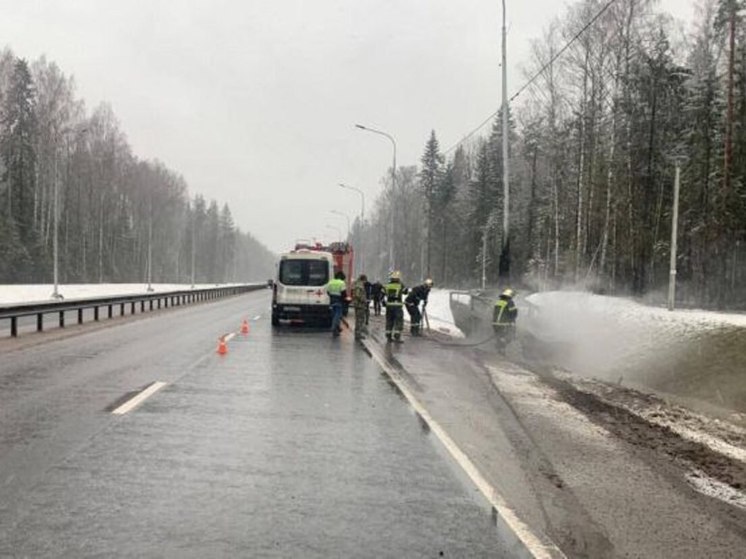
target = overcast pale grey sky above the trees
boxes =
[0,0,694,252]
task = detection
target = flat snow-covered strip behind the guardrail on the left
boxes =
[0,283,248,305]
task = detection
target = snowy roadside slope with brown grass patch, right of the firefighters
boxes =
[519,291,746,410]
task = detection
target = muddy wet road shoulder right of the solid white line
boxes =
[360,324,746,557]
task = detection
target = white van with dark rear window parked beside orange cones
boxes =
[272,249,334,327]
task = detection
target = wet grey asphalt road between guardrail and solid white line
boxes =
[0,292,504,557]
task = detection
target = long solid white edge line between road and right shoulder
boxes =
[363,340,565,559]
